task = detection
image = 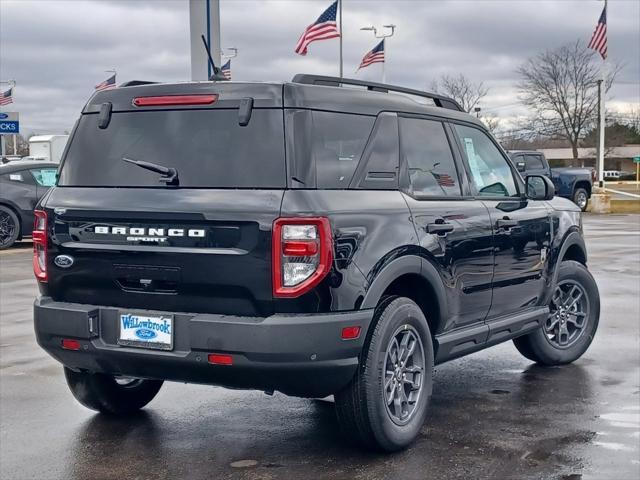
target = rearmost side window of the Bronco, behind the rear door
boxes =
[312,111,375,188]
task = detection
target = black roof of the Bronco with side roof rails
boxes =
[83,75,484,127]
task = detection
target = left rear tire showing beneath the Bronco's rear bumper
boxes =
[64,367,163,415]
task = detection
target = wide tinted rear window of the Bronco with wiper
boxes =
[58,109,286,188]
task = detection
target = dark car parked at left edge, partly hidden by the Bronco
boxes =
[0,160,58,249]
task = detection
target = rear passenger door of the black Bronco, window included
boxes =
[398,116,493,330]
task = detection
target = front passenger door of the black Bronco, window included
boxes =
[453,124,551,319]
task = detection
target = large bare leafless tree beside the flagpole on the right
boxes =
[517,42,620,160]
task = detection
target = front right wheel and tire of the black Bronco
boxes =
[513,260,600,366]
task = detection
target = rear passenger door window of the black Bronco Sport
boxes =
[400,118,461,197]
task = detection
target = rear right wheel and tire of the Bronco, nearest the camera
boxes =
[335,297,433,452]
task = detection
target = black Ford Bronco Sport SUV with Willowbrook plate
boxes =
[33,75,599,450]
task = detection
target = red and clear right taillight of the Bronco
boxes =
[272,217,333,298]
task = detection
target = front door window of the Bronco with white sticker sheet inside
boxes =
[454,125,518,197]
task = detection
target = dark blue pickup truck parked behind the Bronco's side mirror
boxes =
[508,150,595,212]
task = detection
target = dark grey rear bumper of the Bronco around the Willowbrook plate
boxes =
[34,297,373,397]
